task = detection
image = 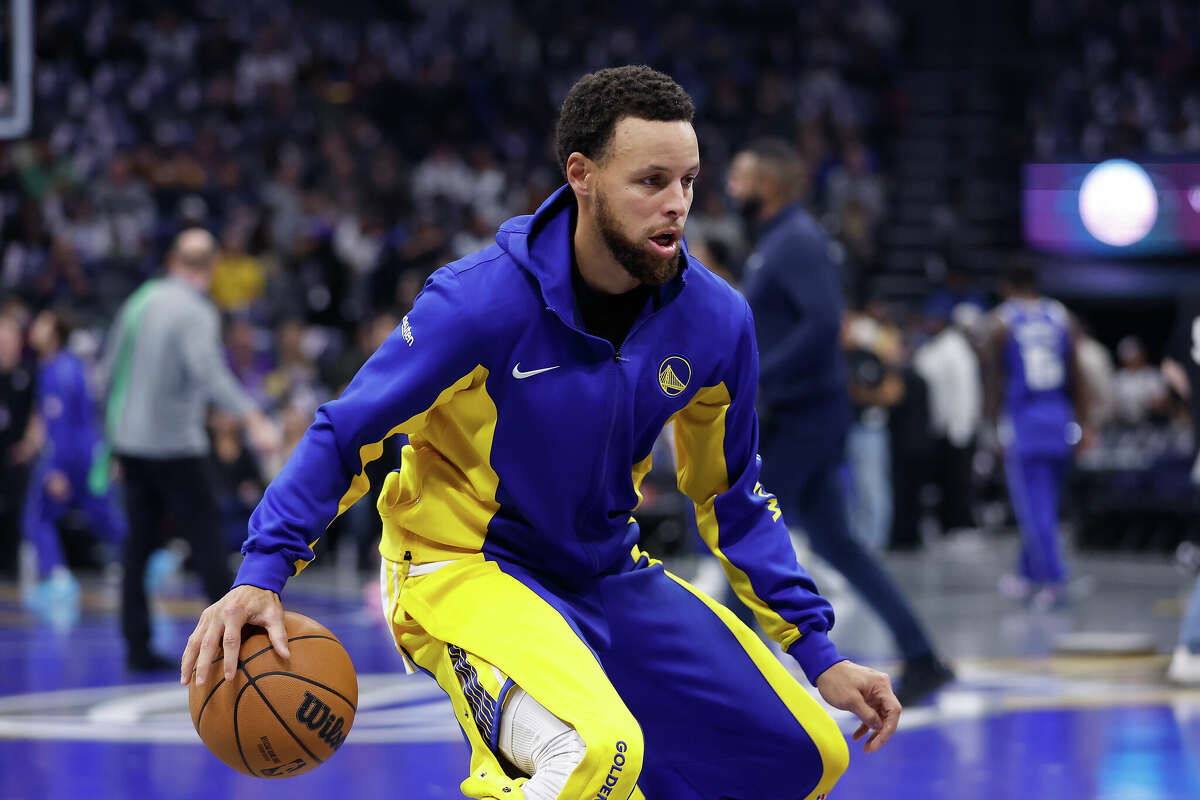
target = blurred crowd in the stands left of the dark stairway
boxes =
[0,0,904,575]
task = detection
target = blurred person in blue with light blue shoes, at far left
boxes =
[23,309,126,624]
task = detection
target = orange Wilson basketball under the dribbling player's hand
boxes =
[188,612,359,778]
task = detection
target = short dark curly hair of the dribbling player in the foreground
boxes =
[554,65,696,175]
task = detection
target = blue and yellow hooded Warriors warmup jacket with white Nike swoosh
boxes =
[236,187,839,680]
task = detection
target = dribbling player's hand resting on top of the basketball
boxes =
[179,584,292,686]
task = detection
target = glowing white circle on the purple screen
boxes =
[1079,158,1158,247]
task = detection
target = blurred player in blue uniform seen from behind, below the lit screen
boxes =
[986,261,1090,609]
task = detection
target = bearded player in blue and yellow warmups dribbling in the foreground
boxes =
[181,67,900,800]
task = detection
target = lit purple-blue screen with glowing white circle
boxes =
[1021,158,1200,255]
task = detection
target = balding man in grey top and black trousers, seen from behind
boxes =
[103,228,270,672]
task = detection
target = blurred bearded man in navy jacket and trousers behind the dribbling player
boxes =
[727,139,953,703]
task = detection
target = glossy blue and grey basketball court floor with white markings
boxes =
[0,537,1200,800]
